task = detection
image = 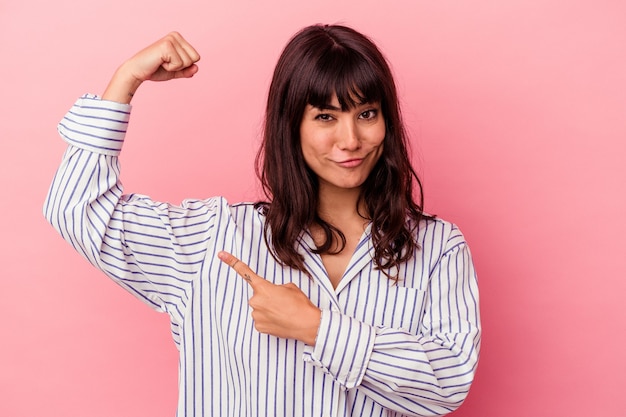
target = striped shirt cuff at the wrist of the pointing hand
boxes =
[304,310,376,389]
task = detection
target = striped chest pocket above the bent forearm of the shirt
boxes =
[359,286,426,334]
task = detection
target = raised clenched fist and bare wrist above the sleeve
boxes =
[102,32,200,103]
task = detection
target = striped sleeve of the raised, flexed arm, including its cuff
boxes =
[44,95,215,314]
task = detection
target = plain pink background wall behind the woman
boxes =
[0,0,626,417]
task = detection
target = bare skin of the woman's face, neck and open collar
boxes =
[300,96,386,288]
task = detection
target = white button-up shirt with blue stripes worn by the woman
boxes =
[44,95,480,417]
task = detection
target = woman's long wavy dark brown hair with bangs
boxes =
[256,25,425,280]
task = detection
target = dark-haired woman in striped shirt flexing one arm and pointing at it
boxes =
[44,25,480,416]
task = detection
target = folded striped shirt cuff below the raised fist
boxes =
[58,94,132,156]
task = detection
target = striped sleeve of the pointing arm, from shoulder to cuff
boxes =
[305,229,481,416]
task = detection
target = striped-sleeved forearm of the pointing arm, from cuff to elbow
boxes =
[305,311,479,416]
